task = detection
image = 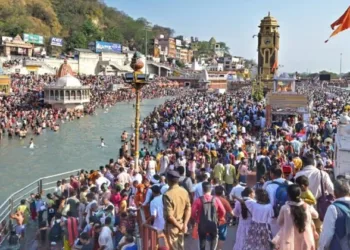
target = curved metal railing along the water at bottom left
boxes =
[0,169,80,245]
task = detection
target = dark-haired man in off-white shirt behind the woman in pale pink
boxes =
[295,153,334,238]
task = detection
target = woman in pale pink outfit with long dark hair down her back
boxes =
[272,184,318,250]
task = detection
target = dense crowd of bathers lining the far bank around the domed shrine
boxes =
[0,74,185,140]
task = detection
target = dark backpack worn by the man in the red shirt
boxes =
[198,196,218,236]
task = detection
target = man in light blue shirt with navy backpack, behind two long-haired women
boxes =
[263,167,291,236]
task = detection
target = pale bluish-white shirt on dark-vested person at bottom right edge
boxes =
[318,197,350,250]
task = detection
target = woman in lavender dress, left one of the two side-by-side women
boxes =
[233,187,254,250]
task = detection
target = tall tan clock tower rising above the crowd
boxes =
[258,12,280,91]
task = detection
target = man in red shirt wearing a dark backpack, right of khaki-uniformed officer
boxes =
[192,182,226,250]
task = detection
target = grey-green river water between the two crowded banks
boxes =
[0,98,168,201]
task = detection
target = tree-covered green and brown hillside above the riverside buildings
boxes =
[0,0,174,51]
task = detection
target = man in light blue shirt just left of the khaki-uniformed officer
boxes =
[147,186,165,231]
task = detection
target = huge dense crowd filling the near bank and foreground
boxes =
[4,80,350,250]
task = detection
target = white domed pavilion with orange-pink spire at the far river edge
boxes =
[44,61,90,110]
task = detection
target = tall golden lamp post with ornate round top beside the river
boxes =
[125,52,149,171]
